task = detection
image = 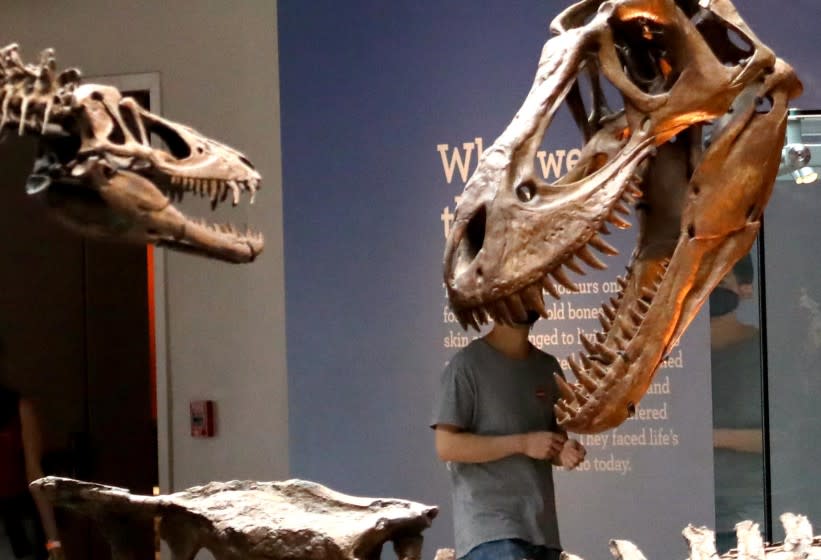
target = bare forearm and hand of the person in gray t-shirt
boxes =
[436,424,566,463]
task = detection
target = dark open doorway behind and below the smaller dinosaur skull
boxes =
[0,78,164,560]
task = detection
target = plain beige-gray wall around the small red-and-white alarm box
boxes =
[0,0,288,489]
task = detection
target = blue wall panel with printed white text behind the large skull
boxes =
[278,0,817,558]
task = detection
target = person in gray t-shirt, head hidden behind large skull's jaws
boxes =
[431,317,586,560]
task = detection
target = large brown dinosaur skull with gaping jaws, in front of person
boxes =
[445,0,801,432]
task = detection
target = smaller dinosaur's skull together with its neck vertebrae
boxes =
[0,45,263,262]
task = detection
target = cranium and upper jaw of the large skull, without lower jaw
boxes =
[445,0,792,316]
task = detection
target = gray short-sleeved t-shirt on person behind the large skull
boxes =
[431,339,561,557]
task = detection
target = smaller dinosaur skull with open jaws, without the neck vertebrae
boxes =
[28,84,264,262]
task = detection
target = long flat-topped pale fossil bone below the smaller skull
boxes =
[32,477,438,560]
